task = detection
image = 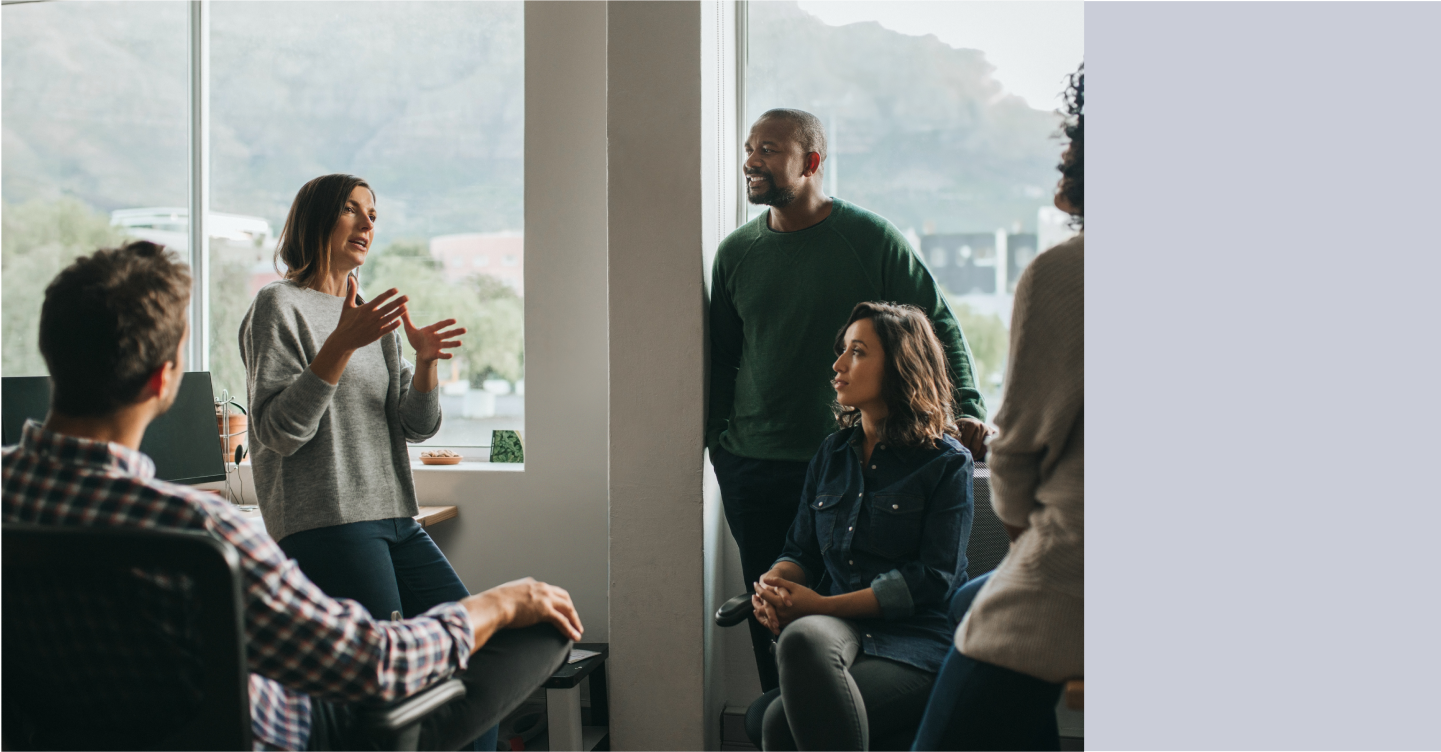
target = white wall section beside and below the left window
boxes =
[415,0,611,641]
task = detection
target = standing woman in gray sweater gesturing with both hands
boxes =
[241,174,468,619]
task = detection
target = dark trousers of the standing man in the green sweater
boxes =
[710,447,817,691]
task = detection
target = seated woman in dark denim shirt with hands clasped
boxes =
[752,303,973,752]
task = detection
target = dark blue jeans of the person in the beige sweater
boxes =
[911,572,1061,752]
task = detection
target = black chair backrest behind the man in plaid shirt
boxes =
[0,524,251,752]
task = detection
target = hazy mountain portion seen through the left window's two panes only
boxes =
[0,0,525,245]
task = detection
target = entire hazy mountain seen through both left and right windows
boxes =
[0,0,1061,237]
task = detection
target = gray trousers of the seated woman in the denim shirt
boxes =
[761,615,935,752]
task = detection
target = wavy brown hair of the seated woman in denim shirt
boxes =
[831,303,960,447]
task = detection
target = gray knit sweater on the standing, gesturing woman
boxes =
[241,281,441,540]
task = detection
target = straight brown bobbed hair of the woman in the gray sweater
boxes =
[275,173,375,287]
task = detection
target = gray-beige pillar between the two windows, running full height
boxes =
[607,0,713,752]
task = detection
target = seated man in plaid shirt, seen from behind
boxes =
[0,242,582,752]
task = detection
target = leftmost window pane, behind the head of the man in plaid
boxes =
[0,0,190,376]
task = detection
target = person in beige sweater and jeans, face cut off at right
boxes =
[912,68,1085,752]
